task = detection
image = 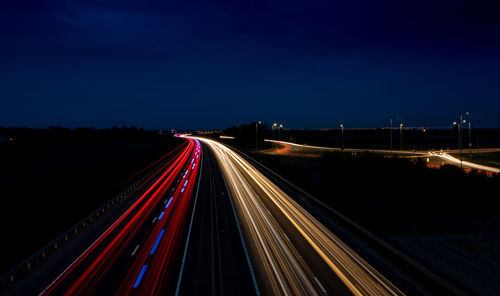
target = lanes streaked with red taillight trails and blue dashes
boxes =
[21,139,201,295]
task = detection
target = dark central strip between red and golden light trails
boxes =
[177,145,256,295]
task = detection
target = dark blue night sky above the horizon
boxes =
[0,0,500,128]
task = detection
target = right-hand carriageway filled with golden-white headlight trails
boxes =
[193,138,403,295]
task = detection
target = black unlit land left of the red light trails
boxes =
[0,127,182,274]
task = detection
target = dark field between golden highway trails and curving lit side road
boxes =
[254,153,500,235]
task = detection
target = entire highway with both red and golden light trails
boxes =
[4,138,460,295]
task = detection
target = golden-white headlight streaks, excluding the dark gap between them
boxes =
[198,138,403,295]
